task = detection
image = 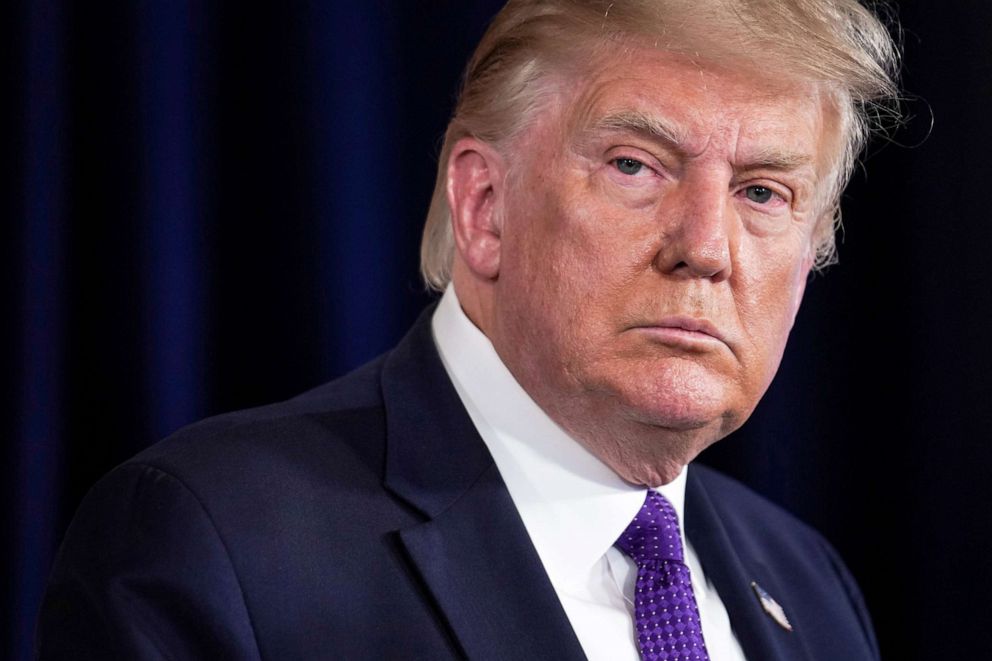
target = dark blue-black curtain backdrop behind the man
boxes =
[0,0,992,659]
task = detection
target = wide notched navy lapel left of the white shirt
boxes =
[382,308,584,659]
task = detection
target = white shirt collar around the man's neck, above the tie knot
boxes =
[432,285,686,586]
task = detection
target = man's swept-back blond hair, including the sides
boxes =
[421,0,899,290]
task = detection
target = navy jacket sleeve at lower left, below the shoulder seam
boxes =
[36,464,260,660]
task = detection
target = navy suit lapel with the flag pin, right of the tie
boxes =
[685,467,810,661]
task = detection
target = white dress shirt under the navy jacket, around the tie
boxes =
[432,285,744,661]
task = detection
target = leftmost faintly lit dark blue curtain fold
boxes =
[12,1,69,658]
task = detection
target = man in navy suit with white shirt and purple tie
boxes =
[39,0,895,661]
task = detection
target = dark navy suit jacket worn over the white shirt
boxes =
[38,313,878,661]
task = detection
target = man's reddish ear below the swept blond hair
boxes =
[447,137,504,280]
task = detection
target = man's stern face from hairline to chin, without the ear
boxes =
[486,49,835,483]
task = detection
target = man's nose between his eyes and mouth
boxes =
[655,178,736,281]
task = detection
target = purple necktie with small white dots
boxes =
[616,491,710,661]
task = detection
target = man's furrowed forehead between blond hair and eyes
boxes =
[560,47,839,175]
